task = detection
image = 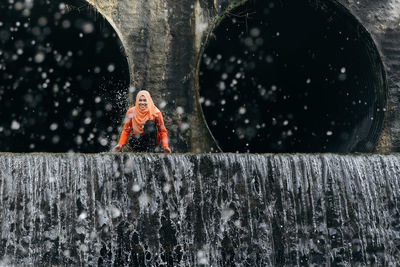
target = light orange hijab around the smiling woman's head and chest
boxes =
[132,90,161,134]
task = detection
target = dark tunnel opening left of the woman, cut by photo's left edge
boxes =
[0,0,129,152]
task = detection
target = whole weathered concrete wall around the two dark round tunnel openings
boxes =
[83,0,400,152]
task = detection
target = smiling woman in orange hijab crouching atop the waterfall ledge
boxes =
[114,90,171,154]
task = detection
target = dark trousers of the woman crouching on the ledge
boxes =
[129,121,157,152]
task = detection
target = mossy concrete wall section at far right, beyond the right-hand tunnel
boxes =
[340,0,400,152]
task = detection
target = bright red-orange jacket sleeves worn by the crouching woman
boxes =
[118,108,168,148]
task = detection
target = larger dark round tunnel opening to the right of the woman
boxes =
[199,0,387,153]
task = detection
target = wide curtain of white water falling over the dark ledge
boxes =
[0,153,400,266]
